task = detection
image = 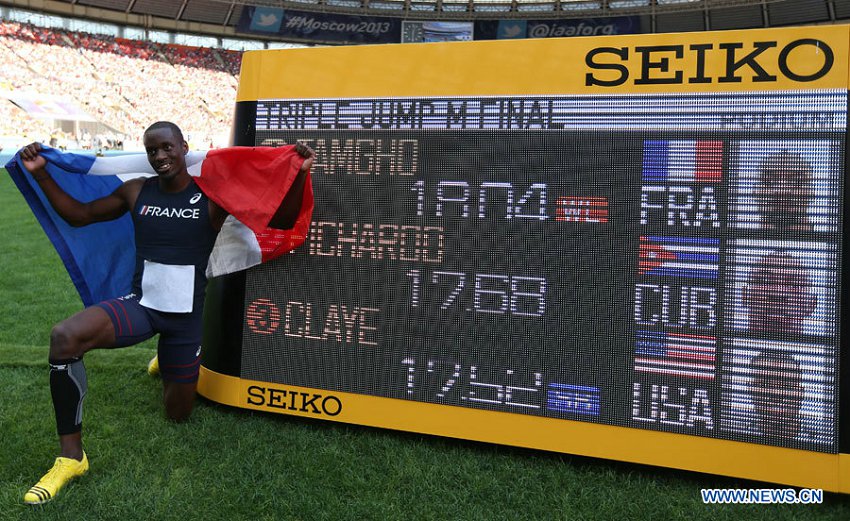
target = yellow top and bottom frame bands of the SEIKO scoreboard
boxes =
[199,26,850,493]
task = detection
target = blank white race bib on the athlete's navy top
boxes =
[139,260,195,313]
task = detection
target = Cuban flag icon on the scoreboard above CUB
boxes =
[638,236,720,280]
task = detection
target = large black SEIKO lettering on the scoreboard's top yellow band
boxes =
[584,38,835,87]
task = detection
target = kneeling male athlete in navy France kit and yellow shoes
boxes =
[21,121,315,504]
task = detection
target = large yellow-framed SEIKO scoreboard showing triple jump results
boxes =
[200,26,850,492]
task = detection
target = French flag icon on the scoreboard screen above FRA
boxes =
[643,141,723,183]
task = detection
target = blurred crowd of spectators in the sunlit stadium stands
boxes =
[0,21,241,150]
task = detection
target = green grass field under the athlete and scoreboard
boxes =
[0,170,850,521]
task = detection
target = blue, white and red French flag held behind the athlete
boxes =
[6,146,313,306]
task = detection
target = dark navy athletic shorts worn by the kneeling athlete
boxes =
[95,293,203,383]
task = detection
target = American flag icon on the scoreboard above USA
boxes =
[635,330,717,380]
